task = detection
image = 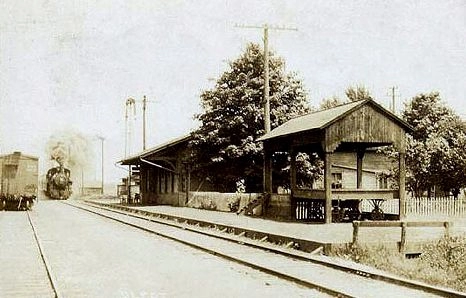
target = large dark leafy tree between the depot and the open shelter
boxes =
[191,44,309,191]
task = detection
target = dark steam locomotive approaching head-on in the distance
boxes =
[45,164,73,200]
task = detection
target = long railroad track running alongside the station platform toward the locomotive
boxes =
[64,202,465,297]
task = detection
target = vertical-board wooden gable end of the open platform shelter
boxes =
[325,105,405,152]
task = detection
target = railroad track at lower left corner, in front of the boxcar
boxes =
[0,211,60,297]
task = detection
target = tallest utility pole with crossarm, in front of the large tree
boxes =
[235,24,298,133]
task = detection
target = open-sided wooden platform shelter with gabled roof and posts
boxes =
[258,99,412,223]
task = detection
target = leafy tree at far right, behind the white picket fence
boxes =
[403,92,466,196]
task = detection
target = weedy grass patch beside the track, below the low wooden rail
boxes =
[333,236,466,292]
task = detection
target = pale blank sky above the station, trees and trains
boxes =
[0,0,466,186]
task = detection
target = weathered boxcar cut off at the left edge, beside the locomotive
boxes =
[0,152,39,210]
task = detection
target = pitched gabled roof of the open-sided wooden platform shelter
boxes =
[258,99,411,141]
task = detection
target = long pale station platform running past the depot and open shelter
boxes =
[82,199,466,251]
